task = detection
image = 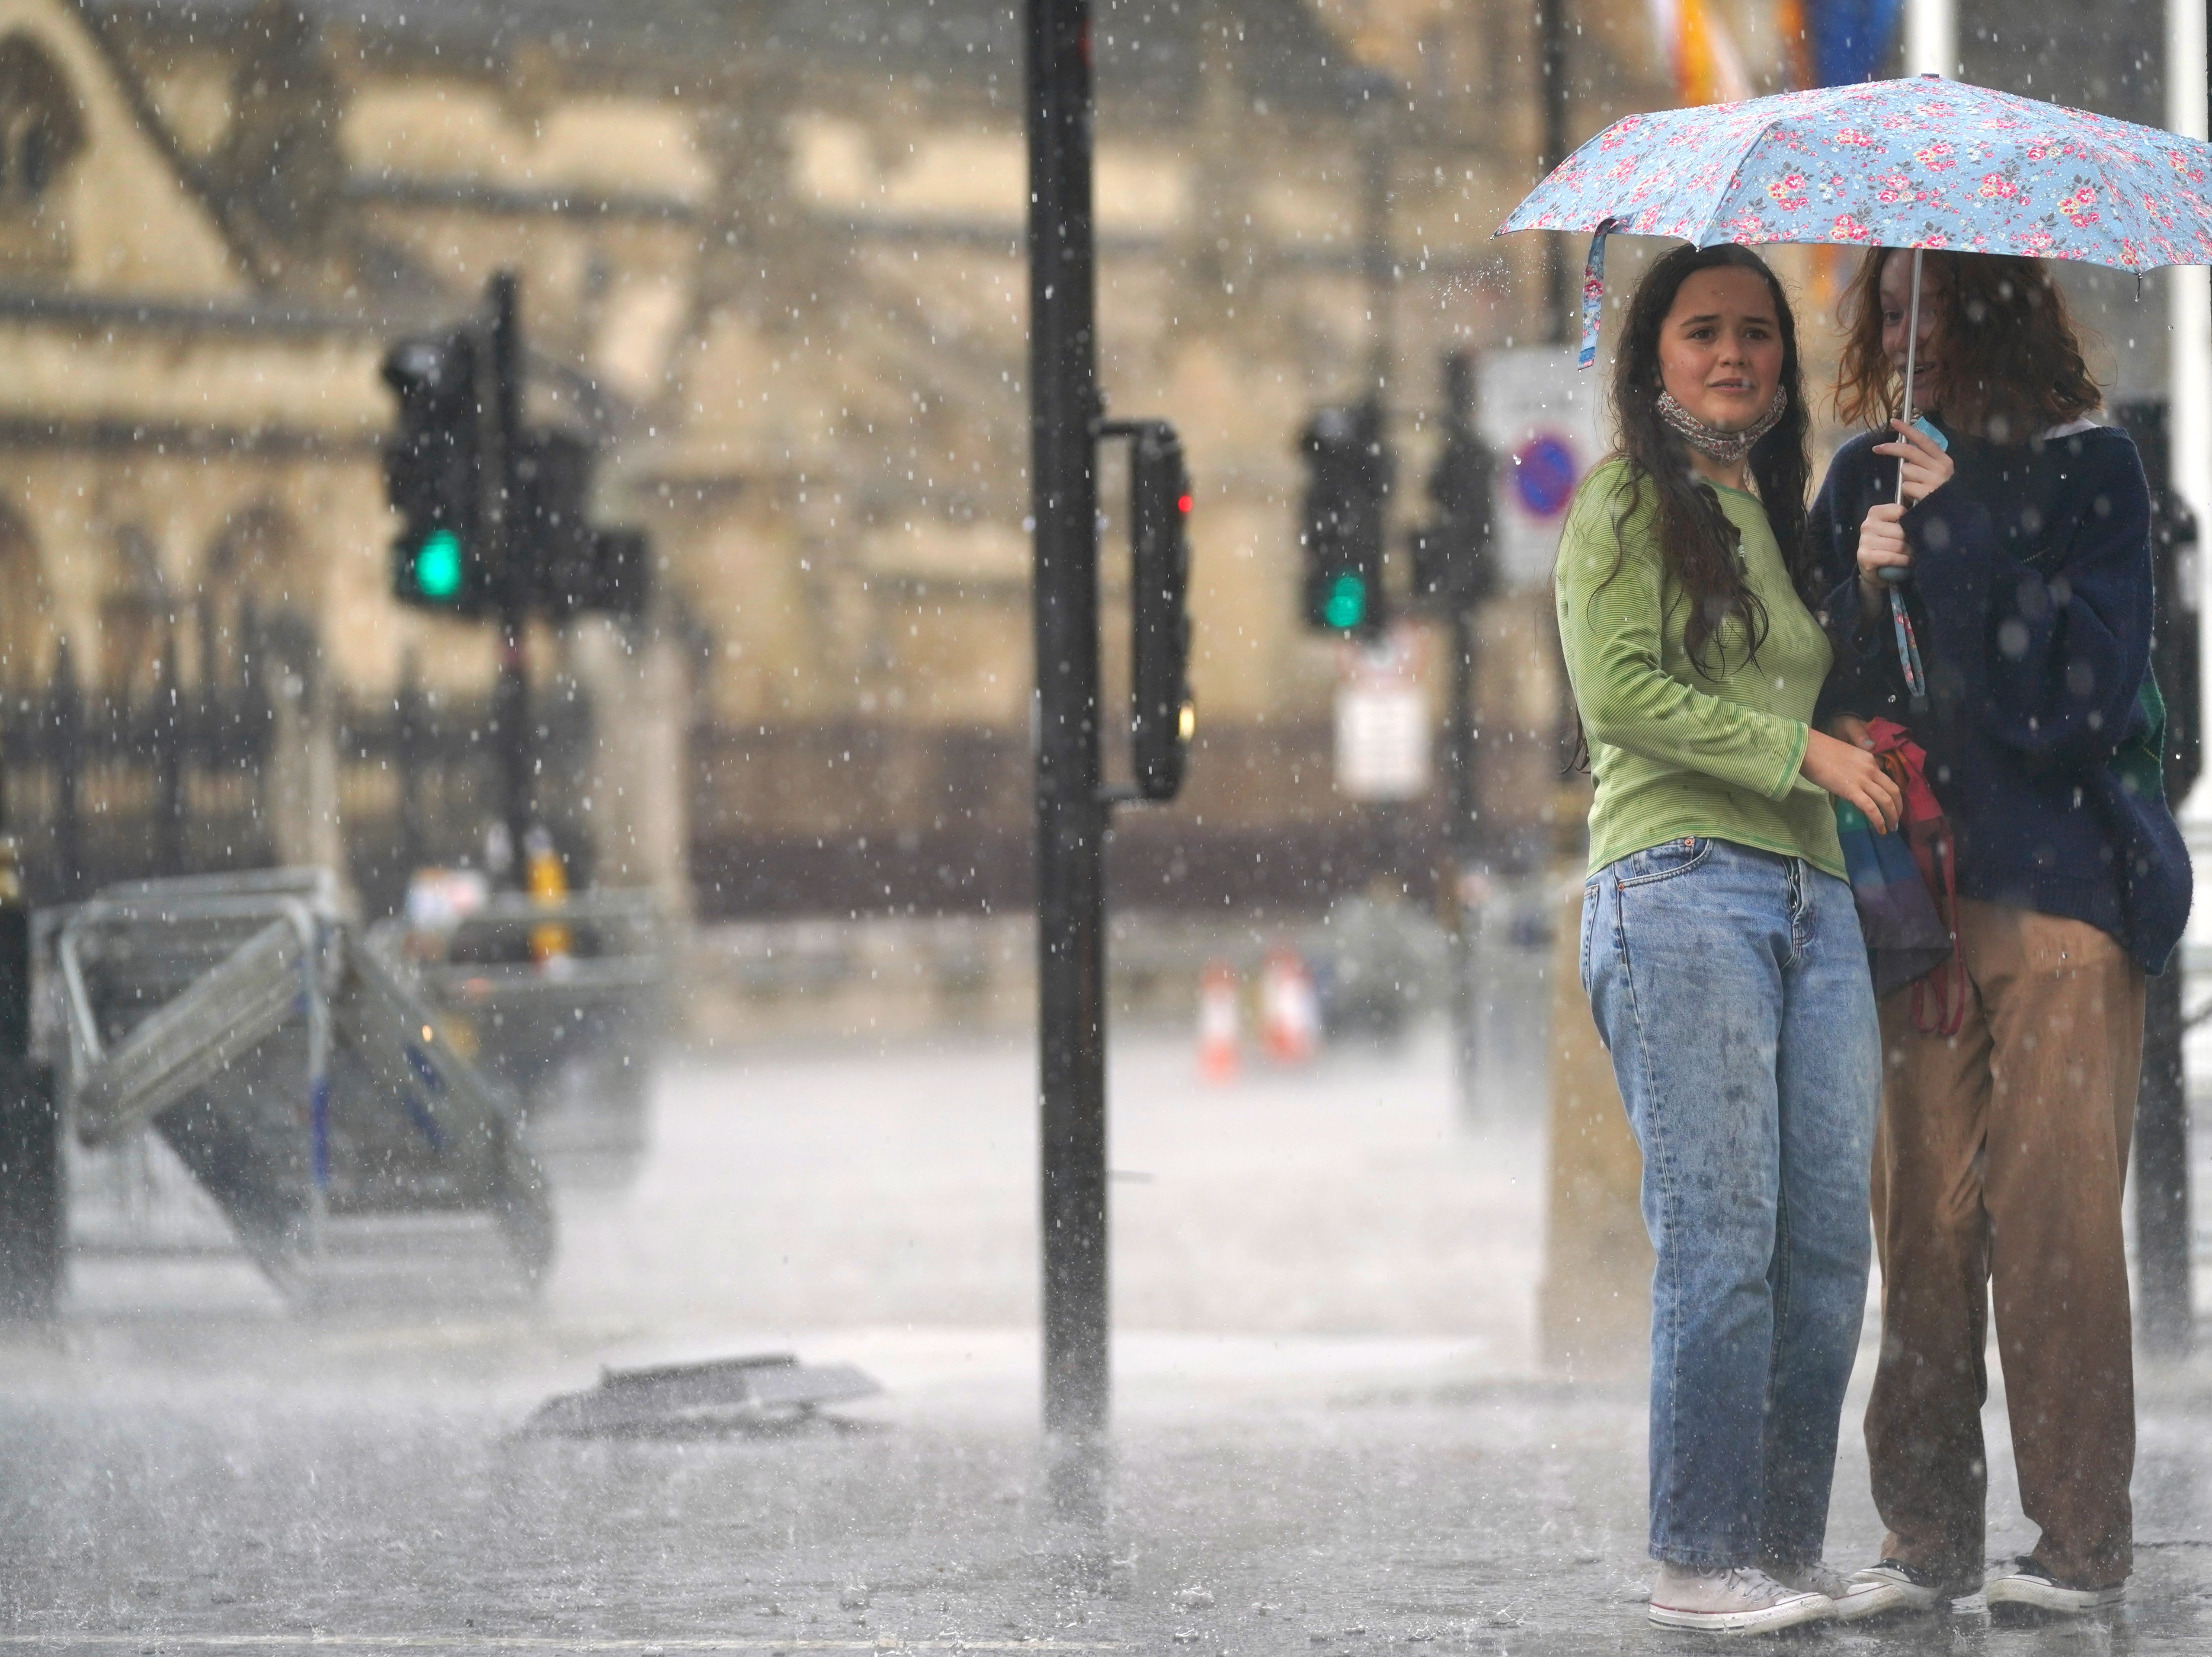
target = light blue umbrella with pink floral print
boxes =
[1498,75,2212,697]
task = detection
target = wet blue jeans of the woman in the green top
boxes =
[1581,838,1882,1568]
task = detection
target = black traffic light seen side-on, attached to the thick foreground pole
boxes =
[1128,420,1197,799]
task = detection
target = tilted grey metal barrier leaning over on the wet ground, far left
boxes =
[55,870,553,1296]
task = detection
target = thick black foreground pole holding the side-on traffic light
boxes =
[1026,0,1108,1522]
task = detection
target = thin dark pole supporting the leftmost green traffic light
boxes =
[480,270,535,887]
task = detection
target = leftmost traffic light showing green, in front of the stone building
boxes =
[385,325,498,615]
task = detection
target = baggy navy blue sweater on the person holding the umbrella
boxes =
[1812,427,2190,971]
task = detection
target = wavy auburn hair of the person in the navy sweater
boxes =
[1836,248,2103,445]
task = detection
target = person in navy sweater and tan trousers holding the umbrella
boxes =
[1814,248,2190,1613]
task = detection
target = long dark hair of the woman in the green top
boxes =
[1606,241,1814,679]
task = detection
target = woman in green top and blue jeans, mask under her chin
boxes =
[1557,246,1900,1631]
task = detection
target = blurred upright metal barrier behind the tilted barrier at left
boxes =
[369,889,670,1188]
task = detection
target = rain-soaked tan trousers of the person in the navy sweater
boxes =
[1867,898,2143,1586]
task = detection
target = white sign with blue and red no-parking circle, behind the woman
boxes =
[1480,345,1604,591]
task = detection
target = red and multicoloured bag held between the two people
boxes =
[1836,719,1966,1035]
